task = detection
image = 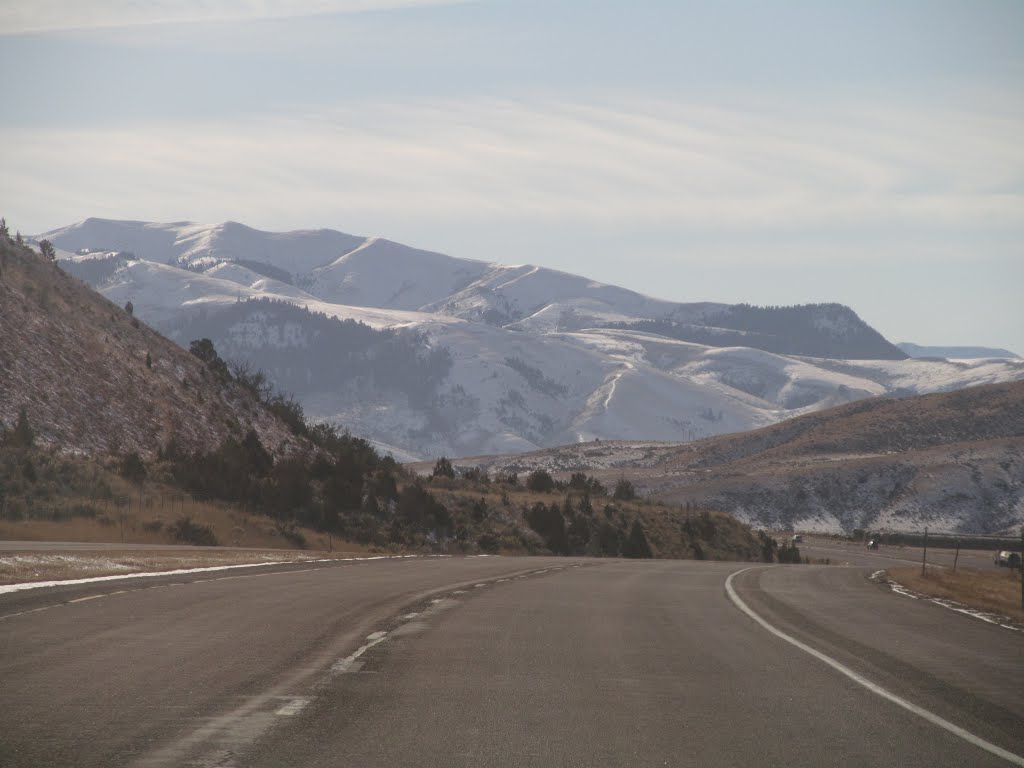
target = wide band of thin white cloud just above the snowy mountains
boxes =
[0,94,1024,232]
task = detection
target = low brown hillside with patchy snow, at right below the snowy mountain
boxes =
[436,382,1024,532]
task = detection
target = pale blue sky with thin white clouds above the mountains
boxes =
[0,0,1024,354]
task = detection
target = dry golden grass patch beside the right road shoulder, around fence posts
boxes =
[889,568,1024,622]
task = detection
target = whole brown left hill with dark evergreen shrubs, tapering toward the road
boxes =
[0,228,766,559]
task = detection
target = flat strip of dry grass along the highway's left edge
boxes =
[0,550,376,585]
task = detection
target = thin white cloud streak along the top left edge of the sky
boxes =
[0,0,472,35]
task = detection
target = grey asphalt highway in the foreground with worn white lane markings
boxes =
[0,558,1024,768]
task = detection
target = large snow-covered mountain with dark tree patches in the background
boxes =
[39,219,1024,459]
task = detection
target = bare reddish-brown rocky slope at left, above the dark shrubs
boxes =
[0,237,296,458]
